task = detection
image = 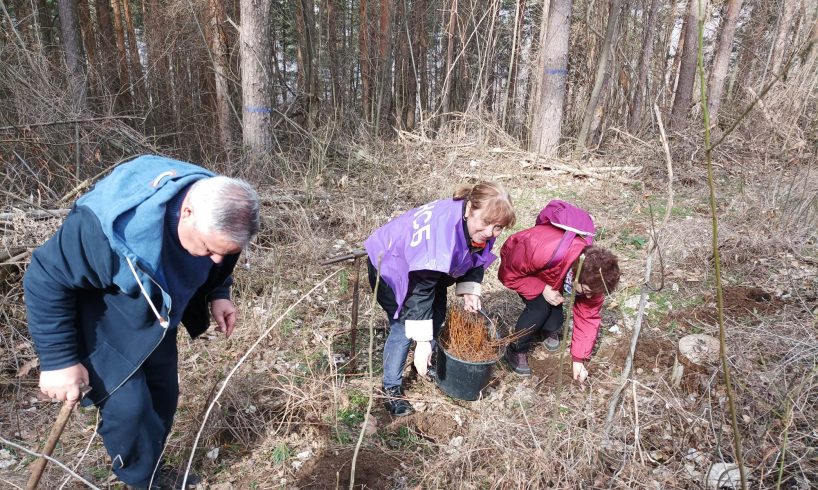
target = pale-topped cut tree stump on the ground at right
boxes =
[670,334,720,391]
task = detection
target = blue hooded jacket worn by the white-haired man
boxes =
[23,156,238,404]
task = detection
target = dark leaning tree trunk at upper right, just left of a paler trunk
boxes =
[670,0,707,131]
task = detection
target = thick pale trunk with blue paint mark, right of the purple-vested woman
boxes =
[530,0,572,156]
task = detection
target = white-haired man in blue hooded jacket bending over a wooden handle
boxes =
[24,156,259,488]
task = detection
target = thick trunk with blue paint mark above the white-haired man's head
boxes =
[240,0,273,152]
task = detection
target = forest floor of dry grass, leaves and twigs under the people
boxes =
[0,128,818,489]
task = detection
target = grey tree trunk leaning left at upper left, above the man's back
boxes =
[57,0,87,113]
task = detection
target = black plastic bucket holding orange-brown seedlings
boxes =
[435,344,499,401]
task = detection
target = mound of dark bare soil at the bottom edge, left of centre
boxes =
[296,448,400,489]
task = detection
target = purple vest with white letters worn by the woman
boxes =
[364,199,497,318]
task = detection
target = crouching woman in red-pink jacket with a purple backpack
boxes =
[498,210,619,381]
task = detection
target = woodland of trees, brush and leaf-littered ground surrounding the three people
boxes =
[0,0,818,488]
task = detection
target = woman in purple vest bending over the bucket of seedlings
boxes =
[364,182,515,416]
